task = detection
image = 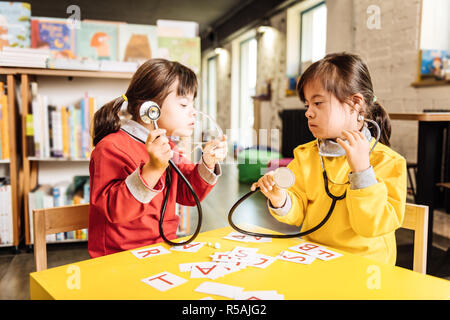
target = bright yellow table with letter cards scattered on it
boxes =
[30,227,450,300]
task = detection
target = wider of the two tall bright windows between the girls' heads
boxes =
[238,37,257,147]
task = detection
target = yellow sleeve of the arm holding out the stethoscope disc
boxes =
[269,157,308,227]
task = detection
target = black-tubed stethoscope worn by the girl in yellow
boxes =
[228,115,381,238]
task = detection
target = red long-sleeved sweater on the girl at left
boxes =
[88,130,215,258]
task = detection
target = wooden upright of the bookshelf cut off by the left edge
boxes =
[0,70,21,252]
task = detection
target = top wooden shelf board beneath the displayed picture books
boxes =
[0,67,134,79]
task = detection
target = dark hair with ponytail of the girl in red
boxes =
[93,59,198,146]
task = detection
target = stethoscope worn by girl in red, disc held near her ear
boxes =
[123,101,203,246]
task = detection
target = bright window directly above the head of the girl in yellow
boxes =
[300,2,327,74]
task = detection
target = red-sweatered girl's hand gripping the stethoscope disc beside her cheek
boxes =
[145,129,173,172]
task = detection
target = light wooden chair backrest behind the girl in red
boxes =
[33,204,89,271]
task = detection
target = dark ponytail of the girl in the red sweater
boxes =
[93,97,125,146]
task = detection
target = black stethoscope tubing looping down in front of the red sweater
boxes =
[122,130,203,246]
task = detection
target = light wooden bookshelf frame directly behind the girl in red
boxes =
[6,67,133,246]
